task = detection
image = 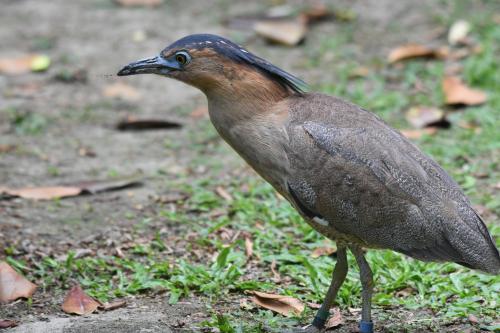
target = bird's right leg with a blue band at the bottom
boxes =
[349,246,373,333]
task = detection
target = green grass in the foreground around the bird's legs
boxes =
[8,179,500,329]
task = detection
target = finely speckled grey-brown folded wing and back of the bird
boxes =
[284,94,500,273]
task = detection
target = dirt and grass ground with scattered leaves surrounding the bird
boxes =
[0,0,500,332]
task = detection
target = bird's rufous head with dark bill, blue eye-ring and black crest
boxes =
[118,34,305,101]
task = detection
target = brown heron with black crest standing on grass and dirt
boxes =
[117,34,500,333]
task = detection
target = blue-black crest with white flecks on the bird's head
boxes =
[167,34,307,93]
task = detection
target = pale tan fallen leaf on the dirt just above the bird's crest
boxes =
[254,18,307,46]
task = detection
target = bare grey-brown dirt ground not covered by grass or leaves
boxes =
[0,0,496,333]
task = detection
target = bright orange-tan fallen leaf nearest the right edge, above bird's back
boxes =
[443,76,488,105]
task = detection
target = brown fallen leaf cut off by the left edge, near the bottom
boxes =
[0,261,36,303]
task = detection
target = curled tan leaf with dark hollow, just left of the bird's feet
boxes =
[251,291,304,317]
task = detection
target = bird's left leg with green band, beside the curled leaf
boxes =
[312,246,347,329]
